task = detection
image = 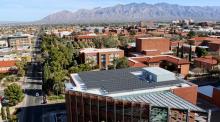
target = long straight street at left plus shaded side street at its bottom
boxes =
[18,37,66,122]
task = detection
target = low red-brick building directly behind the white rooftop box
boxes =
[128,55,190,76]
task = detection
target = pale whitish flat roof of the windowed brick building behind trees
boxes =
[80,48,123,53]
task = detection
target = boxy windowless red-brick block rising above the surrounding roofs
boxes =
[136,37,170,55]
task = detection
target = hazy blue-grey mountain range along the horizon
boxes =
[2,3,220,24]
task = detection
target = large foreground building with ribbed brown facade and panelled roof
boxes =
[65,67,209,122]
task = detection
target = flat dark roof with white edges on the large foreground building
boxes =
[71,68,191,94]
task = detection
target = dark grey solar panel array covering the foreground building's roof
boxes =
[78,68,183,93]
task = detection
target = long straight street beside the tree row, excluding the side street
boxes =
[19,37,43,122]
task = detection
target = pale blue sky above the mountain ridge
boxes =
[0,0,220,21]
